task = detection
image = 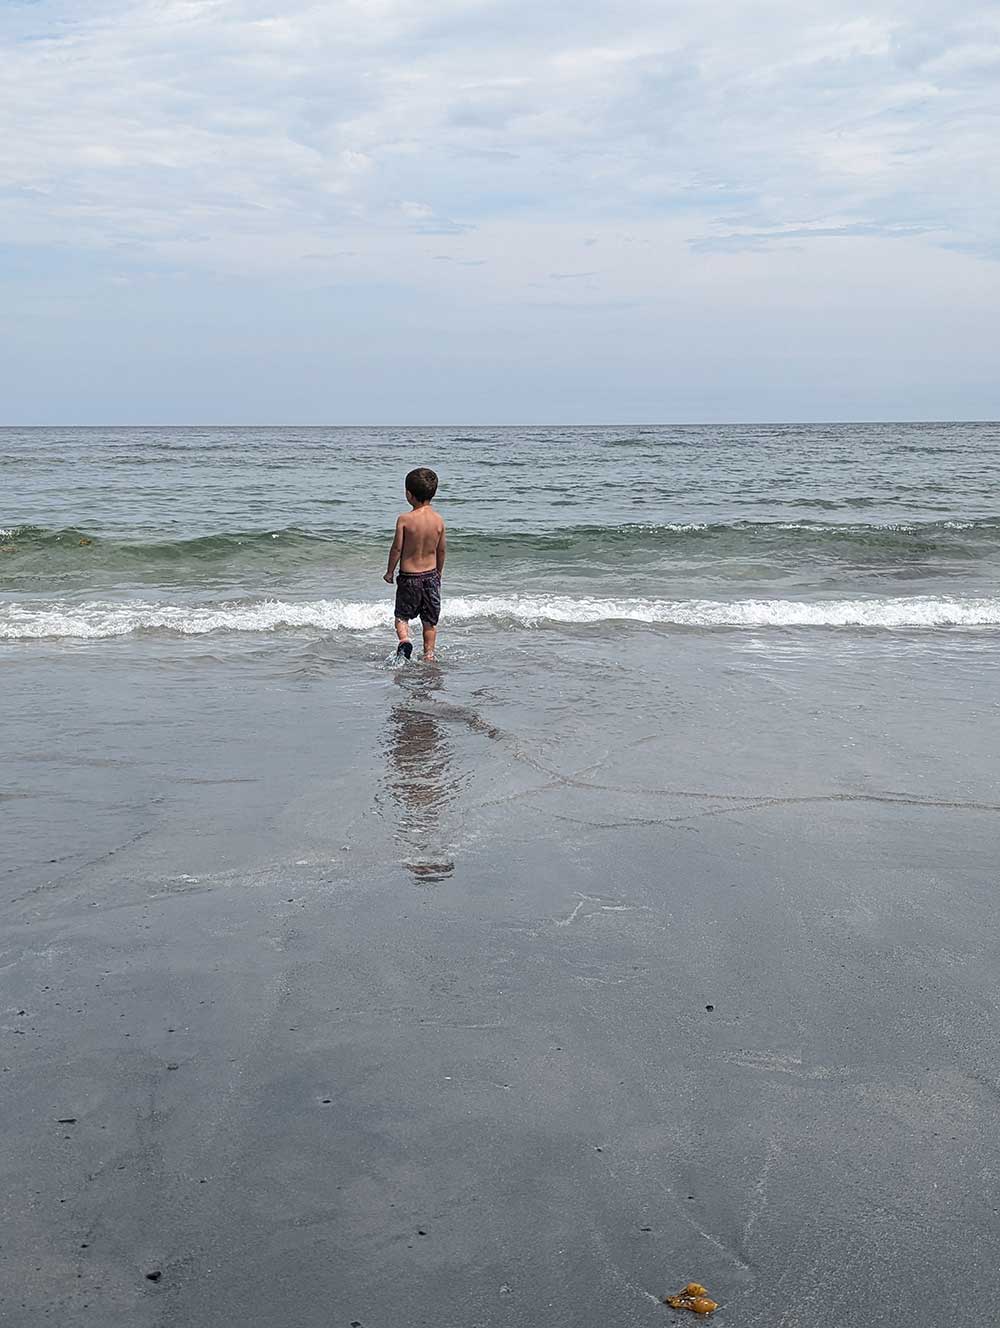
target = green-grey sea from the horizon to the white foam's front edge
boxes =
[0,424,1000,637]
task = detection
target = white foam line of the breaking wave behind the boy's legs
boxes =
[0,595,1000,640]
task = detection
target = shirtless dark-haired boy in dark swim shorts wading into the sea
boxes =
[382,466,445,660]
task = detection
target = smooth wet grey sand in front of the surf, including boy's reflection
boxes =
[0,637,1000,1328]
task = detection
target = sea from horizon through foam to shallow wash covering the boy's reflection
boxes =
[0,424,1000,870]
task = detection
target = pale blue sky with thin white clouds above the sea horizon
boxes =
[0,0,1000,425]
